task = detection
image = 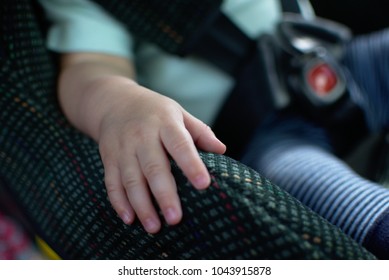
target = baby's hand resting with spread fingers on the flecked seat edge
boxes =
[98,80,225,233]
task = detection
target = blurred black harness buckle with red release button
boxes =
[268,14,362,124]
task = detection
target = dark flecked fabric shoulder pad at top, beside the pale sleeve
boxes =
[94,0,222,54]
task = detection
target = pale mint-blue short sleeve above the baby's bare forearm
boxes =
[39,0,133,59]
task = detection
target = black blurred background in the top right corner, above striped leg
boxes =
[310,0,389,34]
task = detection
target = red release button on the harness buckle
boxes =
[308,63,338,96]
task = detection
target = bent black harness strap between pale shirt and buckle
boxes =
[191,12,273,158]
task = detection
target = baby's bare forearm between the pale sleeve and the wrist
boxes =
[58,53,135,141]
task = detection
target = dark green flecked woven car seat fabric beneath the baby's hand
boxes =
[0,0,374,259]
